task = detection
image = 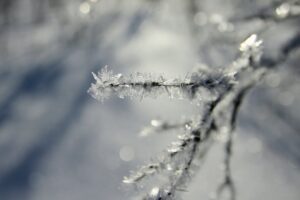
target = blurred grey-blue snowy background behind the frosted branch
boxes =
[0,0,300,200]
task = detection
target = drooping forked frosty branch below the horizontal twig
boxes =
[135,67,265,199]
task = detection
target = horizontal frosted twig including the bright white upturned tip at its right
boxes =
[88,35,261,103]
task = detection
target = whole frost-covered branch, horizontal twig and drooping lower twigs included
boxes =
[89,34,265,199]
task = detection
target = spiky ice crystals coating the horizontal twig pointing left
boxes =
[88,66,234,105]
